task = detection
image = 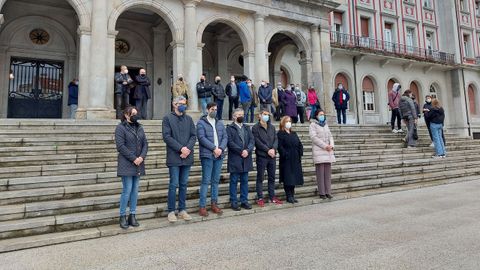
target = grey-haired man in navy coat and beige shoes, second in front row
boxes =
[162,96,197,222]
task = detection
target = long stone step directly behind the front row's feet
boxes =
[0,168,480,239]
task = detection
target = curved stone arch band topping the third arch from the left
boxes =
[197,14,255,52]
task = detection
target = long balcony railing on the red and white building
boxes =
[330,31,455,64]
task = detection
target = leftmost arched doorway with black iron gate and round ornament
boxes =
[0,0,80,118]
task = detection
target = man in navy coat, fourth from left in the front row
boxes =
[227,108,255,211]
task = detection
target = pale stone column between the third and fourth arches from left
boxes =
[254,13,268,84]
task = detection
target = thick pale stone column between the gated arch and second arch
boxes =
[77,1,115,119]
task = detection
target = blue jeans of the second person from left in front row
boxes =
[168,166,191,213]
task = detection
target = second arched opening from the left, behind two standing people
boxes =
[112,6,174,119]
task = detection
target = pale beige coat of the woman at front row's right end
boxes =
[309,120,335,164]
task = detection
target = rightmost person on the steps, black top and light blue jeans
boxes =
[425,99,446,158]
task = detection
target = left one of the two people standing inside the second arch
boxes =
[115,66,133,119]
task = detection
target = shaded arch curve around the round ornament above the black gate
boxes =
[0,16,77,54]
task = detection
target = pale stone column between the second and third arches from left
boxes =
[183,0,201,111]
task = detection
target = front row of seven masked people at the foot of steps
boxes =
[115,96,335,229]
